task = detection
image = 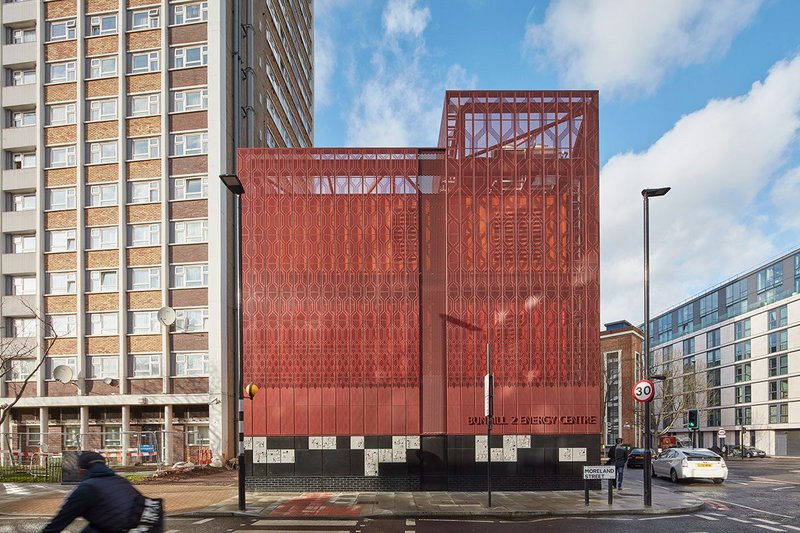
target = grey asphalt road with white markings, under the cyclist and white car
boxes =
[0,458,800,533]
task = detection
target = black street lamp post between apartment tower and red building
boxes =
[219,174,246,511]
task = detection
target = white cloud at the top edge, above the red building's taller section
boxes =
[525,0,762,94]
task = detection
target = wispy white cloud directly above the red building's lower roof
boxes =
[345,0,477,147]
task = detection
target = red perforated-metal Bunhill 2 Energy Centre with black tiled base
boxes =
[239,91,601,490]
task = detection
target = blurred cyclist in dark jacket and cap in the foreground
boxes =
[42,452,144,533]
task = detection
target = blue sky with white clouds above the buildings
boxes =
[314,0,800,323]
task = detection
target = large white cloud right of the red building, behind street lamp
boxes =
[600,56,800,323]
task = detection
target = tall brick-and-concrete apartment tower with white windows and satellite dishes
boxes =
[0,0,313,462]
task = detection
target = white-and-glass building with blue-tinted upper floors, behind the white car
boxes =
[649,250,800,455]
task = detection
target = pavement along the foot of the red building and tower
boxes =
[0,476,704,519]
